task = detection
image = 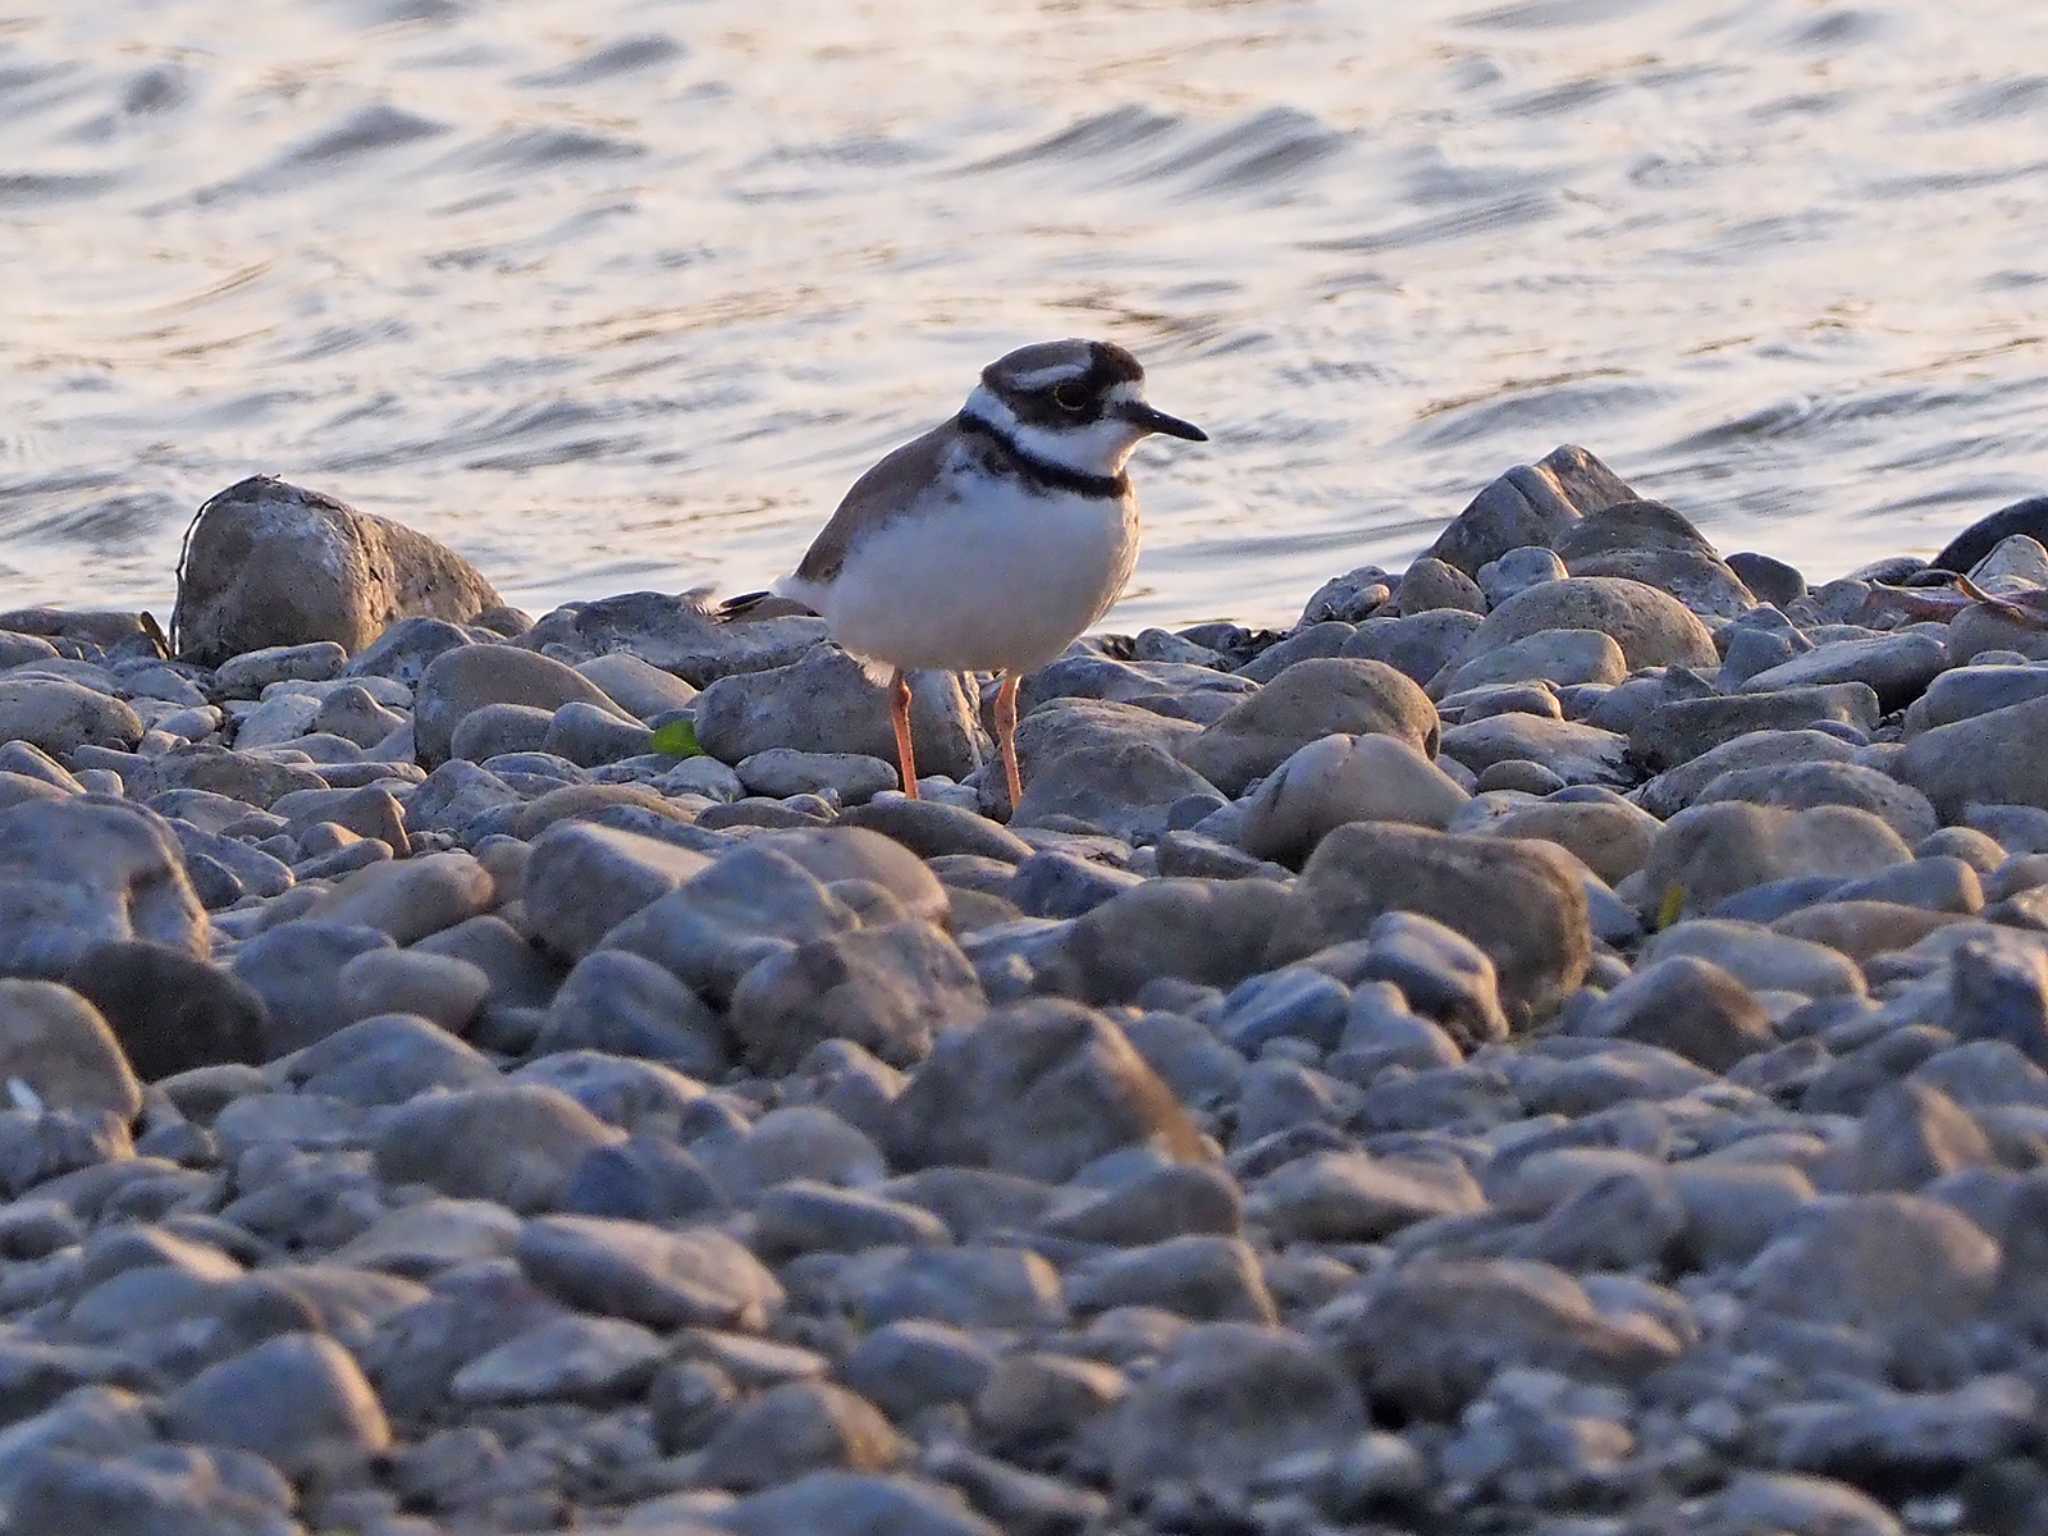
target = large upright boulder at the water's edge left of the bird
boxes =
[170,475,504,666]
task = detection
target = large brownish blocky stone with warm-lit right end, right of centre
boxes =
[1270,821,1593,1022]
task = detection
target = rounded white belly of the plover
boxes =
[819,481,1139,672]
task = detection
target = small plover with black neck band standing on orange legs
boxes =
[719,338,1208,813]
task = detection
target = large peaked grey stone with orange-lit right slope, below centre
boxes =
[889,1001,1202,1180]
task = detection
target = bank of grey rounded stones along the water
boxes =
[0,449,2048,1536]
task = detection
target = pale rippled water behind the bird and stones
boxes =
[0,0,2048,625]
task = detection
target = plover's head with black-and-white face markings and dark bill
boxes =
[963,340,1208,475]
